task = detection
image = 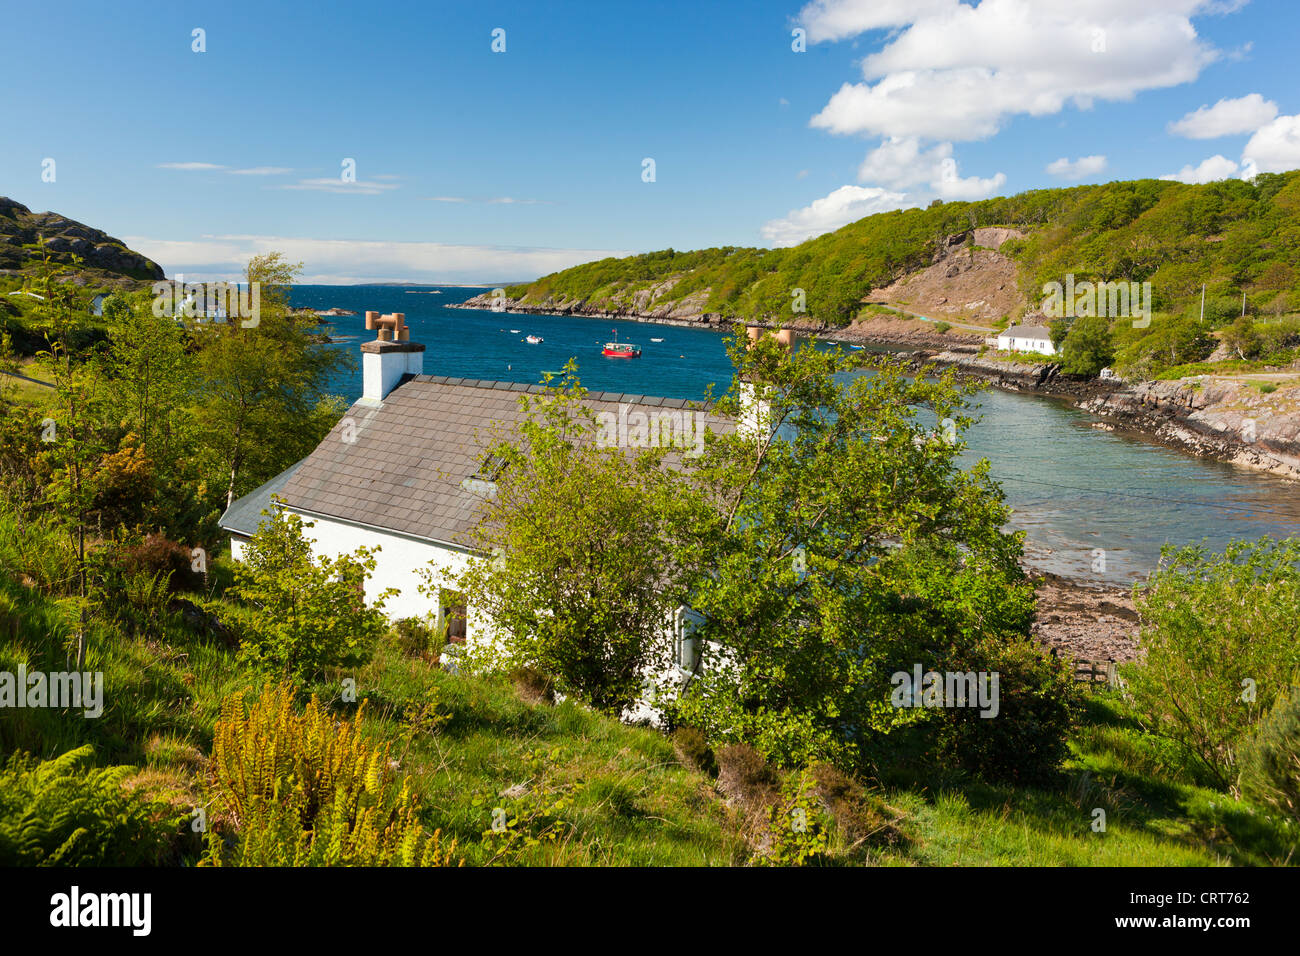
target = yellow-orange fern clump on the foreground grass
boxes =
[205,685,455,866]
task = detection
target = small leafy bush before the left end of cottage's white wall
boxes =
[231,505,390,678]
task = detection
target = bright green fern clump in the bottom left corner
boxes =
[0,747,187,866]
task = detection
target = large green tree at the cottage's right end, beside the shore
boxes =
[672,337,1069,769]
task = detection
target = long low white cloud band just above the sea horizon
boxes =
[124,235,632,284]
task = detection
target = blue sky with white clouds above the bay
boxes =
[0,0,1300,284]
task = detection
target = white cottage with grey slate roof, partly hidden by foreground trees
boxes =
[221,312,735,670]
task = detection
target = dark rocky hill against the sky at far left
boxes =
[0,196,165,289]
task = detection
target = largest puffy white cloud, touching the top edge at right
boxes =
[800,0,1218,140]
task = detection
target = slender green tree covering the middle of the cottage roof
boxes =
[456,363,689,714]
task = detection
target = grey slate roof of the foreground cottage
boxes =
[271,375,735,548]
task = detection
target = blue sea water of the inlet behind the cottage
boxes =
[294,286,1300,584]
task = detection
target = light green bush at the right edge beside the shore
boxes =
[1128,538,1300,788]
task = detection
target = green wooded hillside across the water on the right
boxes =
[508,172,1300,325]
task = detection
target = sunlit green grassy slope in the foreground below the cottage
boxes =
[0,553,1295,865]
